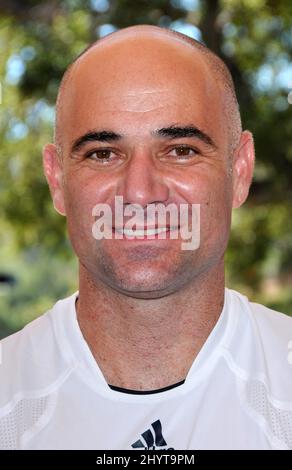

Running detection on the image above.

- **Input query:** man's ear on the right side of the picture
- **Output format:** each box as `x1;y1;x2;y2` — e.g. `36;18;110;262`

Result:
232;131;255;208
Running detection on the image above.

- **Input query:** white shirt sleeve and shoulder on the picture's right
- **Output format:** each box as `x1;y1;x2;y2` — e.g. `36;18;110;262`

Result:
222;289;292;449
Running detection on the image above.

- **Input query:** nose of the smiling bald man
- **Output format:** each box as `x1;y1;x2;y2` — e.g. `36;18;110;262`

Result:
119;149;169;207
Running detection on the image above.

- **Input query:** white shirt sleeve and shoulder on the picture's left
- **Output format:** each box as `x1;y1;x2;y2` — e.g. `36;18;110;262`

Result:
0;294;75;450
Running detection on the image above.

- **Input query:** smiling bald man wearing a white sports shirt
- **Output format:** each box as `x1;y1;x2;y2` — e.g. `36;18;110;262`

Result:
0;26;292;450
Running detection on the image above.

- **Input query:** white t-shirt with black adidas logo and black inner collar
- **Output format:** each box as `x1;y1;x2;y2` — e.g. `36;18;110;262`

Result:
0;289;292;450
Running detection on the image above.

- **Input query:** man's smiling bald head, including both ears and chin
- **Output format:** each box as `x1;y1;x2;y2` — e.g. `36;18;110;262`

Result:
44;26;254;297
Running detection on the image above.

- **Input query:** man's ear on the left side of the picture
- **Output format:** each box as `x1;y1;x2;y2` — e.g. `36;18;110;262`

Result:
43;144;66;215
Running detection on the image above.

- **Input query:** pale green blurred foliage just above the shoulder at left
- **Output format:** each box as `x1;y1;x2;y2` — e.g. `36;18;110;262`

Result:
0;227;78;337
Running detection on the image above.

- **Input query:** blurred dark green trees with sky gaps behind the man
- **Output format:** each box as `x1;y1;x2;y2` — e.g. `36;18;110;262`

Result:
0;0;292;338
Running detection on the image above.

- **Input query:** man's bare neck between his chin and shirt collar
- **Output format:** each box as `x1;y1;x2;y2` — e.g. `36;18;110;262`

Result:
77;260;224;390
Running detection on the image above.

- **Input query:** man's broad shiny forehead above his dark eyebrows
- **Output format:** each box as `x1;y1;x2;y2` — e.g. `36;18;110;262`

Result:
61;34;226;146
